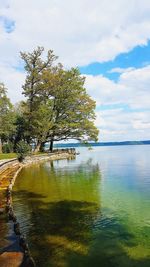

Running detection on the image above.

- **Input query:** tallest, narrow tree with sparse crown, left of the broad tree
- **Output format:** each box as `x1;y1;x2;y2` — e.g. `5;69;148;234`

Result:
21;47;57;150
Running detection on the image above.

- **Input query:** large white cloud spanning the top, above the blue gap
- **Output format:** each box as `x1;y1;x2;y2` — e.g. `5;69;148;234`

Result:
0;0;150;66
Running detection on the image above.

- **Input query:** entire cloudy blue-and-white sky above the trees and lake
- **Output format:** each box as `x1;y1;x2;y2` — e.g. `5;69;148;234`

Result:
0;0;150;141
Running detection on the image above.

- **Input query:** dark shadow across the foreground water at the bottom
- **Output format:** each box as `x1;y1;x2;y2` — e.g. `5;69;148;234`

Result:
12;191;150;267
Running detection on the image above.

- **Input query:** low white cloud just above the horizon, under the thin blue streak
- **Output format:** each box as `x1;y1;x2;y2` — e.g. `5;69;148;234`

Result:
96;109;150;141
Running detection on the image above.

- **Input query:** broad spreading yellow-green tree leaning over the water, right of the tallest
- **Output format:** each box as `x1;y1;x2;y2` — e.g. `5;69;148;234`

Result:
44;68;98;151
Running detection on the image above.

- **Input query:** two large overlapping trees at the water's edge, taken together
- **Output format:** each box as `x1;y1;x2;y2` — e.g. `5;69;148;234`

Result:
21;47;98;151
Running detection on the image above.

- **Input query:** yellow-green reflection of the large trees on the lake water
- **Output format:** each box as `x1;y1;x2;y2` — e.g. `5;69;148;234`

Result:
14;159;101;267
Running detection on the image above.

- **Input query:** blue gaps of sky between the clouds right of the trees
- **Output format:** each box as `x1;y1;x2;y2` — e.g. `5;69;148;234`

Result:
79;41;150;112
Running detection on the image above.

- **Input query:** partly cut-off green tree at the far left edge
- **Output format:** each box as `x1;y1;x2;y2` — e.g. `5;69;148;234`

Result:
0;83;15;153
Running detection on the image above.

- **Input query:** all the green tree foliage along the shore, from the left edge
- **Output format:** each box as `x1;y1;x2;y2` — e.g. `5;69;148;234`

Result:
0;47;98;154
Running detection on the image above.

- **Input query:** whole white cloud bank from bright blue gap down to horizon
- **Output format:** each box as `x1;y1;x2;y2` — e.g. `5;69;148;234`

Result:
86;66;150;141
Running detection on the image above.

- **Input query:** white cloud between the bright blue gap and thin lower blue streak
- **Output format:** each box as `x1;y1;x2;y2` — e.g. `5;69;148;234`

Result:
86;65;150;108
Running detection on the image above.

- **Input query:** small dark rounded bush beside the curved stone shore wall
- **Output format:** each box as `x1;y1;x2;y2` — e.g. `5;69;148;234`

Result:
16;141;31;162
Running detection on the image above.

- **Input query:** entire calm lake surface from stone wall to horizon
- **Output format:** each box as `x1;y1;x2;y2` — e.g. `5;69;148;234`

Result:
13;146;150;267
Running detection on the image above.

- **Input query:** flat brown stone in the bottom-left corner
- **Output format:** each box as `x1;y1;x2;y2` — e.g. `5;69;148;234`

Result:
0;252;24;267
